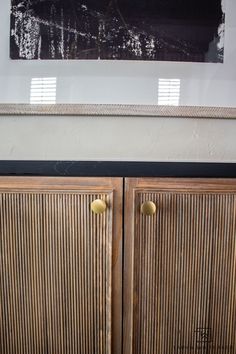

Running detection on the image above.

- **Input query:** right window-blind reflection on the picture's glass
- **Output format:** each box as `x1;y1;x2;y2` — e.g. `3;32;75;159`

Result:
158;79;180;106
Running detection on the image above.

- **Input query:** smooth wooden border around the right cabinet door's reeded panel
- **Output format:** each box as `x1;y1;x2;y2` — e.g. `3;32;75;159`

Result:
123;177;236;354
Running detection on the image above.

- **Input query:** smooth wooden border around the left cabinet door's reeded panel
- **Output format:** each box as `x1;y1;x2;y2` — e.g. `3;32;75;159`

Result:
0;176;123;354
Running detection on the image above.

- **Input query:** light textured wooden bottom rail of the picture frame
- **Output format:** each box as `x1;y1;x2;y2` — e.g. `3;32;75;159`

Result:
0;103;236;119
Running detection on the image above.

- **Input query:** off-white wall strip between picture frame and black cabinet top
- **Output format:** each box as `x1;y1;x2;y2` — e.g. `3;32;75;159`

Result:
0;117;236;162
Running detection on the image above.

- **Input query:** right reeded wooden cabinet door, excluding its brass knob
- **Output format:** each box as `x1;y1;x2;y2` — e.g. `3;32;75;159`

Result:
124;178;236;354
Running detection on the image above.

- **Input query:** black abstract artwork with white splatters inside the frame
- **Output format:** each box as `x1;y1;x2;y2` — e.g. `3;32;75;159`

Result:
10;0;225;63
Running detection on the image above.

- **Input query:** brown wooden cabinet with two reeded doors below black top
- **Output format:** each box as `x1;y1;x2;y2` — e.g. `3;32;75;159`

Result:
0;177;236;354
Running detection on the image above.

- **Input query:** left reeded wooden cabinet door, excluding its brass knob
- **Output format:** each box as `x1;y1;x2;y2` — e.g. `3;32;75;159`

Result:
0;177;122;354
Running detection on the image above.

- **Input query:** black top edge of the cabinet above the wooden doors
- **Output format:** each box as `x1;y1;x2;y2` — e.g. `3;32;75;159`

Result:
0;160;236;178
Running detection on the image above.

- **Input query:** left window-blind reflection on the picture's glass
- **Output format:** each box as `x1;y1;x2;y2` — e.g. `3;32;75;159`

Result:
30;77;57;104
